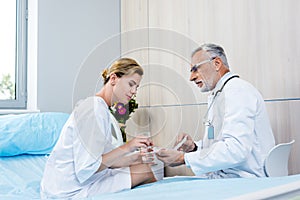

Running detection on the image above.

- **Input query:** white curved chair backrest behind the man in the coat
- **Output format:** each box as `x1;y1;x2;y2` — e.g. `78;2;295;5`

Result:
264;140;295;177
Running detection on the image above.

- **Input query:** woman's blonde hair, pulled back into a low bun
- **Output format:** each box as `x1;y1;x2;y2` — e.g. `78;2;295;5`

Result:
102;58;144;85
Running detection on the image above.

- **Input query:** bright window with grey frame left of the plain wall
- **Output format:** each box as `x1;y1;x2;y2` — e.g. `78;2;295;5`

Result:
0;0;27;109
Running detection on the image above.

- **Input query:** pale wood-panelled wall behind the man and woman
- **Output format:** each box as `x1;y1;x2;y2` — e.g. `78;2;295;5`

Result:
121;0;300;175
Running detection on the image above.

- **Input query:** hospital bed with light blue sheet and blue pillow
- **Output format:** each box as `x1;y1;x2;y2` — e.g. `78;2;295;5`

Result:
0;113;300;200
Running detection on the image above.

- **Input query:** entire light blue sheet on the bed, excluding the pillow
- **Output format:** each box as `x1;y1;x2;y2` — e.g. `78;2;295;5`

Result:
0;155;300;200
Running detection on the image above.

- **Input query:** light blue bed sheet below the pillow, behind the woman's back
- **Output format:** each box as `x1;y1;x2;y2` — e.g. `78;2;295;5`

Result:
0;155;47;200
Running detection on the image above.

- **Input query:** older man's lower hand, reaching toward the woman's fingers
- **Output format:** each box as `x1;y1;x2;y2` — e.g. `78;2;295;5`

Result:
156;149;185;167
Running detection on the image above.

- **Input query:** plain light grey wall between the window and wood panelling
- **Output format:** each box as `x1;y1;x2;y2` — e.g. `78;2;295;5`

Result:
37;0;120;112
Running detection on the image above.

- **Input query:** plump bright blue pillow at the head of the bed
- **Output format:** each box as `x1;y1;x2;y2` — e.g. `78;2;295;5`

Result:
0;112;69;156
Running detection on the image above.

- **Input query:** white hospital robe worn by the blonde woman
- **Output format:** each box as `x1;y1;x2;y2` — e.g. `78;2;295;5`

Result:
41;97;131;198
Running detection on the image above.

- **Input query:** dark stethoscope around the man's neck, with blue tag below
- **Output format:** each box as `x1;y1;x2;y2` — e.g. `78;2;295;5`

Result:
203;75;239;140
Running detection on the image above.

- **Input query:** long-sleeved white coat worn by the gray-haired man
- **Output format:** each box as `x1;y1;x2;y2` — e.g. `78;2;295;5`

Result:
185;72;275;178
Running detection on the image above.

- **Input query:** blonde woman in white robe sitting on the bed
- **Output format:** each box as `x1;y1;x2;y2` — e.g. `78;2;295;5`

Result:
41;58;156;199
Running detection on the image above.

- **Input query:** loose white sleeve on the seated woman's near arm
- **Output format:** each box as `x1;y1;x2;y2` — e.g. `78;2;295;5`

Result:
73;98;110;183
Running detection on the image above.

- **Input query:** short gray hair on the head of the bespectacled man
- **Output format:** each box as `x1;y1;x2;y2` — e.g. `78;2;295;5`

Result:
192;43;229;68
